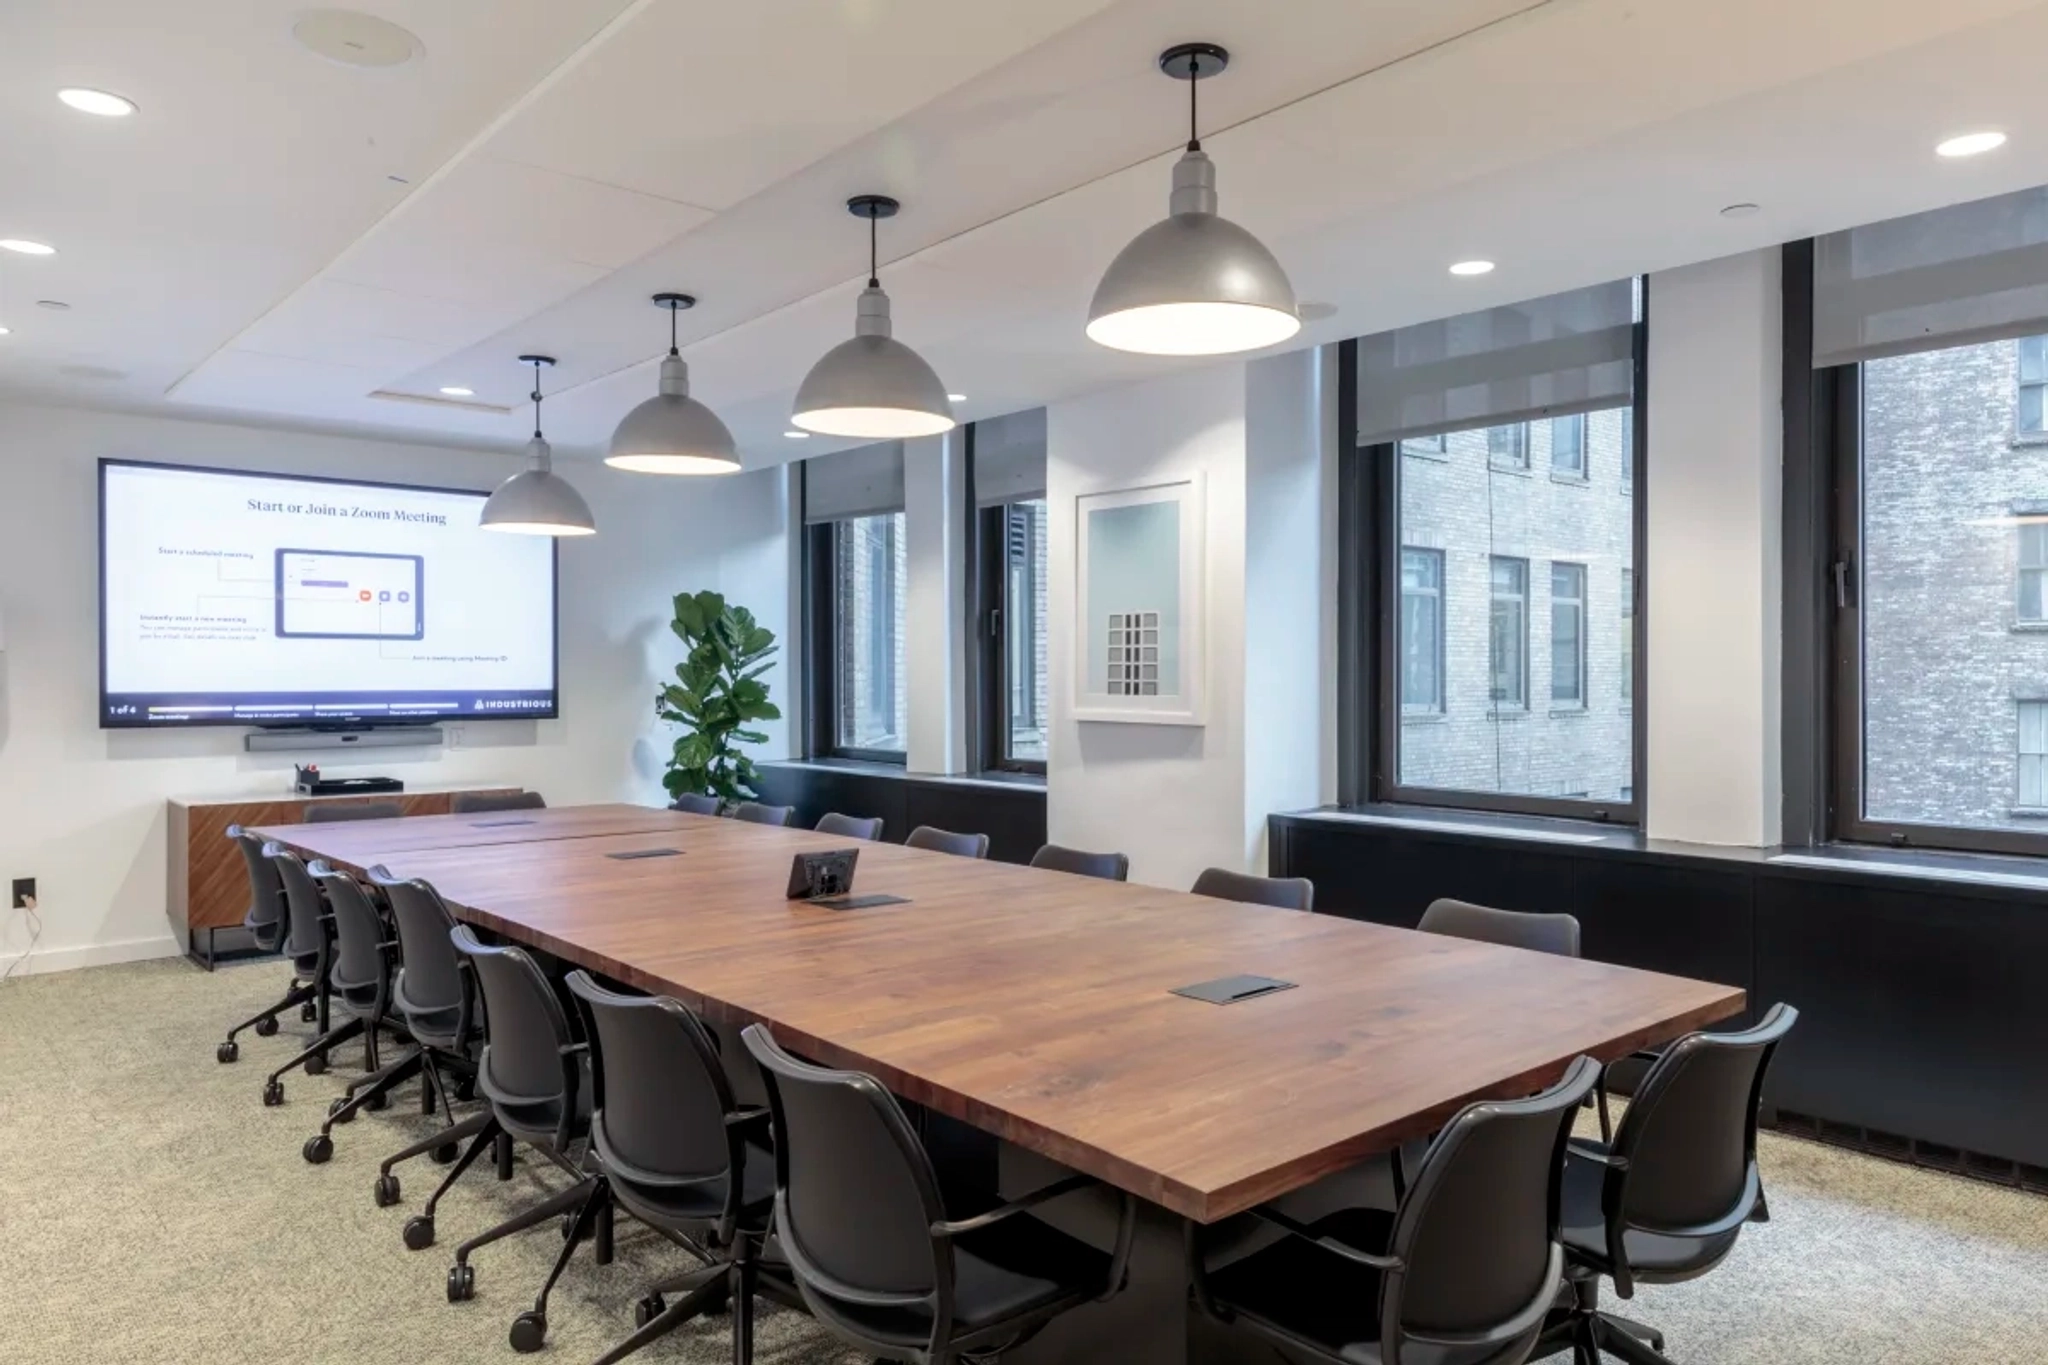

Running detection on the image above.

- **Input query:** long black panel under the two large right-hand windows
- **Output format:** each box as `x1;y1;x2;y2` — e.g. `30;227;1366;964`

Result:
1270;814;2048;1169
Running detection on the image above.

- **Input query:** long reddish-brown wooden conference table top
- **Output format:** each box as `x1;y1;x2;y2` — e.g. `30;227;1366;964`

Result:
266;814;1743;1222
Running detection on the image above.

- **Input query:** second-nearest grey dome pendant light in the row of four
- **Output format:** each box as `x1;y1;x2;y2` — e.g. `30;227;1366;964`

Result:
791;194;954;440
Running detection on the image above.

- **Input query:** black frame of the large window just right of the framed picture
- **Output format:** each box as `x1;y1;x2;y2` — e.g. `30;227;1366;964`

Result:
1337;276;1653;827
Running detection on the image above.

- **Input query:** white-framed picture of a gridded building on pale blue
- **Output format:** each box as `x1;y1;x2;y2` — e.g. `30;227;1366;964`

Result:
1069;471;1208;726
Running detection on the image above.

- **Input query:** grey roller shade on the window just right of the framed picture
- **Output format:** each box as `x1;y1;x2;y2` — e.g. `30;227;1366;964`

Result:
1358;280;1636;446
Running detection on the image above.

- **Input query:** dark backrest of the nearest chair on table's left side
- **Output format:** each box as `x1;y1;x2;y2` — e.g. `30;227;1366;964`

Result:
741;1023;952;1340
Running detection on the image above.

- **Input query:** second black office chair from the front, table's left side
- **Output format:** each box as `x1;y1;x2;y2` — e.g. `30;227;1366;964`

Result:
569;970;797;1365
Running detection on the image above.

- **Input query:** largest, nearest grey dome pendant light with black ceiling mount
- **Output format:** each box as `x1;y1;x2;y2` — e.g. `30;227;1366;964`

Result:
1087;43;1300;356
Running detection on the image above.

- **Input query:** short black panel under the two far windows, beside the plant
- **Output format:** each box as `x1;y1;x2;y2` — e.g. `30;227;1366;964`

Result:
758;763;1044;864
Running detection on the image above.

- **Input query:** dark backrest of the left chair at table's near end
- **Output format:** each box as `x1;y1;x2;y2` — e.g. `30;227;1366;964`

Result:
1380;1056;1599;1365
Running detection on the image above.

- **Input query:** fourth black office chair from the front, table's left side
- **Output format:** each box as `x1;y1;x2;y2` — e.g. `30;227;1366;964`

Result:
369;868;492;1209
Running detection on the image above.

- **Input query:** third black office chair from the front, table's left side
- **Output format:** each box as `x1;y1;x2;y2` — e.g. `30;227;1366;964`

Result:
438;925;612;1353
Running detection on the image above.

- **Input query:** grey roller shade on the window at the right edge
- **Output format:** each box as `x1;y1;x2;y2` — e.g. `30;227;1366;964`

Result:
1812;190;2048;368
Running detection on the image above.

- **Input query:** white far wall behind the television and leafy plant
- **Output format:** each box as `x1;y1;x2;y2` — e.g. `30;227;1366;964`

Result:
0;394;788;970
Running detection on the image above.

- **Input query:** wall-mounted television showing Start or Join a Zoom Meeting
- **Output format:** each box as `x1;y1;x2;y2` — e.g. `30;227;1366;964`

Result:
100;460;559;729
